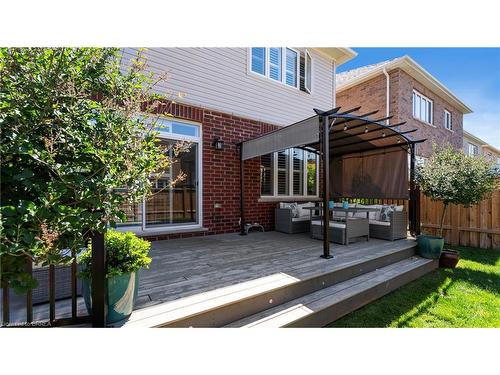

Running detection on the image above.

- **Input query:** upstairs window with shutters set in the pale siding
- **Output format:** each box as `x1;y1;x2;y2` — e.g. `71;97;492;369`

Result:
250;47;312;93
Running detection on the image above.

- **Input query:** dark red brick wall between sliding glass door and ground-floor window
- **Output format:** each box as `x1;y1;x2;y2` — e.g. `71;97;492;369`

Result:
143;103;276;240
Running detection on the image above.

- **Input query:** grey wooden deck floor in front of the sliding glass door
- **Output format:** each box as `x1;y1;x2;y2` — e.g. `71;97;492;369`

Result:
5;232;422;321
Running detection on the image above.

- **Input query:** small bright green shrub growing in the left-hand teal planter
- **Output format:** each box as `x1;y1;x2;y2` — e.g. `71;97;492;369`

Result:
78;230;151;279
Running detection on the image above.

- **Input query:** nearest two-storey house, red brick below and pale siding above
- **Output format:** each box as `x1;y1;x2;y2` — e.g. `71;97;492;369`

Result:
122;47;356;239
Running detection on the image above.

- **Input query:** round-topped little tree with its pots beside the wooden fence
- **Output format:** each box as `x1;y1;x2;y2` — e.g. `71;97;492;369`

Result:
416;146;498;268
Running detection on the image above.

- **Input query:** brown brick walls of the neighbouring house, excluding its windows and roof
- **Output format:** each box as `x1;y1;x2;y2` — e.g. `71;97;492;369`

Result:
337;69;463;157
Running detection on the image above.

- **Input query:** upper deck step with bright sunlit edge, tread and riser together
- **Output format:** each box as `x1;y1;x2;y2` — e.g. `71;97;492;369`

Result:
118;242;415;328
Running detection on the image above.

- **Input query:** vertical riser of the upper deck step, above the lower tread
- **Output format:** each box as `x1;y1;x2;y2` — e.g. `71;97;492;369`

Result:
157;247;416;328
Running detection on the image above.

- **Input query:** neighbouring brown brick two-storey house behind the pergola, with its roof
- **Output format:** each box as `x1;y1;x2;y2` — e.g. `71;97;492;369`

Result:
337;56;472;158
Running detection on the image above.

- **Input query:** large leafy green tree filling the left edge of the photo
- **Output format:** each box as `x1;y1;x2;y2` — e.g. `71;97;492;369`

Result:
0;48;184;292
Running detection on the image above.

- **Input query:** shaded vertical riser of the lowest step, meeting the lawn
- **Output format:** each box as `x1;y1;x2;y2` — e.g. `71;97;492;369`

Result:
283;260;439;328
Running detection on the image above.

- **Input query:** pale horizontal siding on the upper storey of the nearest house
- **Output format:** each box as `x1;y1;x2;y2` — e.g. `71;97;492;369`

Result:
122;48;334;126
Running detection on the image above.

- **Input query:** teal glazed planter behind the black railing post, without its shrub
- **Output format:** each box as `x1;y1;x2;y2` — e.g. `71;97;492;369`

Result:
82;272;139;324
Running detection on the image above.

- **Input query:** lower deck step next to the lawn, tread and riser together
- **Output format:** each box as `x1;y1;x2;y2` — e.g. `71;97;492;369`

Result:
226;256;437;328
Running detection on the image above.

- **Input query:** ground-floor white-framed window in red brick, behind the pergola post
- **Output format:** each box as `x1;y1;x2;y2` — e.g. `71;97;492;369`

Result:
260;148;318;197
